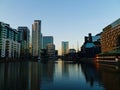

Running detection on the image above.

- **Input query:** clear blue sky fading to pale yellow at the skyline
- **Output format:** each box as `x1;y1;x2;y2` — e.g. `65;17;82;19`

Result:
0;0;120;54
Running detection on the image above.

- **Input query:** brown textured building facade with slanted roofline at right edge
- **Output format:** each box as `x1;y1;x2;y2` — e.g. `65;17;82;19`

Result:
101;19;120;53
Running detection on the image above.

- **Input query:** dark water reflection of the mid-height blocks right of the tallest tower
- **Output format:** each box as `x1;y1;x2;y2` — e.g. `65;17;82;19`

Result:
41;62;55;90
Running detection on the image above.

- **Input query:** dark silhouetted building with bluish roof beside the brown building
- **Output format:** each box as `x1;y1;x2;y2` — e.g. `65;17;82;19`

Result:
81;33;101;57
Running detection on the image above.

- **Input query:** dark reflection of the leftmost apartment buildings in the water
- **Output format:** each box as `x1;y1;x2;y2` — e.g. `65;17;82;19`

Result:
0;63;29;90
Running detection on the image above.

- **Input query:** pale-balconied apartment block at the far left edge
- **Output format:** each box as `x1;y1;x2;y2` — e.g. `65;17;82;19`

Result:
0;22;20;58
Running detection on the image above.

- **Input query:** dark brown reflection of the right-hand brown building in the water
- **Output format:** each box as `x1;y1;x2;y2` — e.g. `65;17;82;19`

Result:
99;65;120;90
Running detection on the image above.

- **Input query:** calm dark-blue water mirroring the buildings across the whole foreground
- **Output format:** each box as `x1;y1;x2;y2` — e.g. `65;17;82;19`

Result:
0;60;120;90
